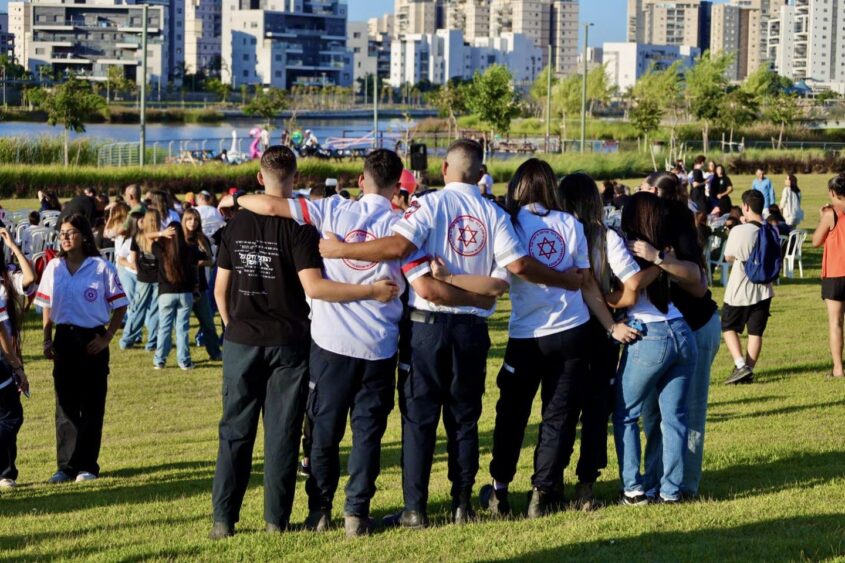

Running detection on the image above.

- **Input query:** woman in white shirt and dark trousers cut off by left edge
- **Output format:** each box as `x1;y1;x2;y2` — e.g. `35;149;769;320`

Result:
0;227;35;489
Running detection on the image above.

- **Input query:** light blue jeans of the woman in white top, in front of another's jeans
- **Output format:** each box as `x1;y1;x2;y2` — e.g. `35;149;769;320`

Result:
613;319;698;499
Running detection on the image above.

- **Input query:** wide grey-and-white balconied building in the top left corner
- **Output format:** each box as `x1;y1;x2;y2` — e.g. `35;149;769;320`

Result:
9;0;166;85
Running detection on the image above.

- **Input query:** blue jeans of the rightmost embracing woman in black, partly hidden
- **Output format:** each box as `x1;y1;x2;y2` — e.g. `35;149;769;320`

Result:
643;312;722;496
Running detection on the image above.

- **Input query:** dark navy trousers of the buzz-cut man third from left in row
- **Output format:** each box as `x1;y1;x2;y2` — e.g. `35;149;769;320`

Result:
399;313;490;511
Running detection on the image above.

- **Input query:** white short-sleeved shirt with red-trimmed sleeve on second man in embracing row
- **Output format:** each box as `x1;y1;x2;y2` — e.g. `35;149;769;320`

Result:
288;194;405;360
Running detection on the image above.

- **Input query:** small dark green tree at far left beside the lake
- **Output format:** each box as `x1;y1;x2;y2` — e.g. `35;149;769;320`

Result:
36;77;105;166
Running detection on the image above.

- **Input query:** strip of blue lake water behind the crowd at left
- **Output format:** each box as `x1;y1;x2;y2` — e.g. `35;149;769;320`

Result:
0;118;406;149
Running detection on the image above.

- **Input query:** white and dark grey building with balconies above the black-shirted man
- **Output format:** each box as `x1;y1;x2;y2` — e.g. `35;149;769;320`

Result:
221;0;353;88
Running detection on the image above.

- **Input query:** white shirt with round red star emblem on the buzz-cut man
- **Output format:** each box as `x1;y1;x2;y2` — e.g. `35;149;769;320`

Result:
393;183;525;318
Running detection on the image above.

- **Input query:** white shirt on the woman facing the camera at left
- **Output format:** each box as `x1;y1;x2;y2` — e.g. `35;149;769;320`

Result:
35;256;129;328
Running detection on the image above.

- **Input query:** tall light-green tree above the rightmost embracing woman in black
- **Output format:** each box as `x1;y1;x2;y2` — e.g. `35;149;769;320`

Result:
685;51;733;154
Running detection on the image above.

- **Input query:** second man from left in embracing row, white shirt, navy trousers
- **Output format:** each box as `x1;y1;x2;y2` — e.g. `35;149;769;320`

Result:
214;149;493;537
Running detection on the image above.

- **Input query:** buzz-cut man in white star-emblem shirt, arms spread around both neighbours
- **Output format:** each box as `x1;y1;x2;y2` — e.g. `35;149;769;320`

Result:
320;139;600;528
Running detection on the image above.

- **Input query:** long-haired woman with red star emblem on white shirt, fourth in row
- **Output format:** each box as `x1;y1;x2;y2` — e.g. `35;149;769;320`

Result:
481;158;633;518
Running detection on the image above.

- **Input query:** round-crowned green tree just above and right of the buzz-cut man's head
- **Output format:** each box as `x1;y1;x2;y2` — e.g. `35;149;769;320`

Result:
467;65;519;133
